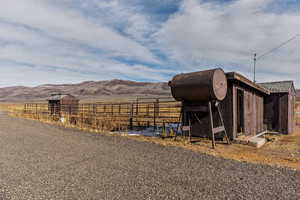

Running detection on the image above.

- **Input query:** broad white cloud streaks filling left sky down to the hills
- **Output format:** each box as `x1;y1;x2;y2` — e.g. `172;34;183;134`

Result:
0;0;172;86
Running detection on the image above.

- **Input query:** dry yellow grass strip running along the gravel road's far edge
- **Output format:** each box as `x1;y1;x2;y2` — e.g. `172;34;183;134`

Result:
0;102;300;170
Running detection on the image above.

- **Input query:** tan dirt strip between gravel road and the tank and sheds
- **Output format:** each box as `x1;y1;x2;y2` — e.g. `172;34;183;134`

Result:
127;128;300;170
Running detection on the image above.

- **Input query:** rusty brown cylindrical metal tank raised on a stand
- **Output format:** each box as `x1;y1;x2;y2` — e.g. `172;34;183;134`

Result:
169;68;227;102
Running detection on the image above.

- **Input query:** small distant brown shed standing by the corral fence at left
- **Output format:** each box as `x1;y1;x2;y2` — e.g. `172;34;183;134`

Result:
48;94;79;115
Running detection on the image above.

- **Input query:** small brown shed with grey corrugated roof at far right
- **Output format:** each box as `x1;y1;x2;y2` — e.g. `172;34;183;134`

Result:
260;81;296;134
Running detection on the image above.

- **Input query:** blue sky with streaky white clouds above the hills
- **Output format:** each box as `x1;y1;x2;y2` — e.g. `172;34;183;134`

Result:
0;0;300;87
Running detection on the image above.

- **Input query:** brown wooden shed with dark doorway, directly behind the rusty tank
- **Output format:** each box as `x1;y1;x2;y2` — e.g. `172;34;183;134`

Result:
185;72;270;140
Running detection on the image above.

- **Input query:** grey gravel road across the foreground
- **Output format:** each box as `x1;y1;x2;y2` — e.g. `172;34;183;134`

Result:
0;113;300;200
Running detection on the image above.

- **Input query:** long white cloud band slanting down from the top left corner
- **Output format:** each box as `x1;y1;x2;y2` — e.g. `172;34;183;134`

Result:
0;0;158;62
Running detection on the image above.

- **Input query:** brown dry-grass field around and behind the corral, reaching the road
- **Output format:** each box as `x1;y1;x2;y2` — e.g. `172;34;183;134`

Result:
0;102;300;170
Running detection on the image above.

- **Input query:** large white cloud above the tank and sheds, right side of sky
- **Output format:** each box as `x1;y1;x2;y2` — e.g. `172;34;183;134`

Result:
157;0;300;84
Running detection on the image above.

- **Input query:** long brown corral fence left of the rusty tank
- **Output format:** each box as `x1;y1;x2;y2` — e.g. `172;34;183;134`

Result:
5;98;181;131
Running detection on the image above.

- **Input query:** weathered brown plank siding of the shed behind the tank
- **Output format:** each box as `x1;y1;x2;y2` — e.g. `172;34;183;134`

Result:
191;83;265;139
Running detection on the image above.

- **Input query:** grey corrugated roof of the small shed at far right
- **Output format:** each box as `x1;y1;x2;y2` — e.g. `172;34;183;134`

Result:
259;81;294;93
